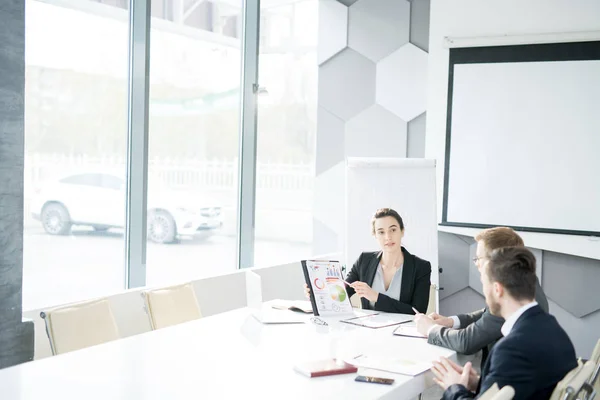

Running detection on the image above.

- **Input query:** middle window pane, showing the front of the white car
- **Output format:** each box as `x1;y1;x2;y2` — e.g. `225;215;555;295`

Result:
146;0;242;286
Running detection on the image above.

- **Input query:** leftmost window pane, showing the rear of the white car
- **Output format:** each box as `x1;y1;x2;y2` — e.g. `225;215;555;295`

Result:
23;0;128;310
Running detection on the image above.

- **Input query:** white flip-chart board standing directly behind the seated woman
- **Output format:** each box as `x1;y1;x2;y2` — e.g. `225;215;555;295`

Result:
344;158;439;296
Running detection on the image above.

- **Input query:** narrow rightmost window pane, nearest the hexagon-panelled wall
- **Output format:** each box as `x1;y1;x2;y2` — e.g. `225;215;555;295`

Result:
254;0;318;265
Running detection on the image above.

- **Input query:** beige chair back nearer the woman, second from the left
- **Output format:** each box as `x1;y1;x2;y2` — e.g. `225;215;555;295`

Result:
142;283;202;329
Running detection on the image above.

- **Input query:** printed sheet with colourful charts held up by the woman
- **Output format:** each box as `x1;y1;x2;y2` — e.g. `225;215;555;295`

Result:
302;260;353;317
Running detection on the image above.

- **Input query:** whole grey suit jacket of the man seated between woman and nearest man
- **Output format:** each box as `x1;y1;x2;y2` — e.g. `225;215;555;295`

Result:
427;280;548;356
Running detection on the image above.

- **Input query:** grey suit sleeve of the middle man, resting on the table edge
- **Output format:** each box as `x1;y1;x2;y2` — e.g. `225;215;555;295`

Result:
427;310;504;354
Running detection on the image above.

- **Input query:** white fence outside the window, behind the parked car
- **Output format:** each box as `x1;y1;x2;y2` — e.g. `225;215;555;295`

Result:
24;154;315;243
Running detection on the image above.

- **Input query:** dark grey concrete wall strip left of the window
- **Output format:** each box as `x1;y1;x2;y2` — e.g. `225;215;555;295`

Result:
0;0;33;368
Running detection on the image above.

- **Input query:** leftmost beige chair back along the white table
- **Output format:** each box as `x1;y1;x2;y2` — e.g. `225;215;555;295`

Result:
40;299;120;355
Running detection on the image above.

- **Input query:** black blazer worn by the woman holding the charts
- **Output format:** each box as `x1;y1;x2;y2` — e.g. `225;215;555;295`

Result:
346;247;431;314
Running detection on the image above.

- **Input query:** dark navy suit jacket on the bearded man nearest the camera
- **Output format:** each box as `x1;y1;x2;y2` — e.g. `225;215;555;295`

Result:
442;306;577;400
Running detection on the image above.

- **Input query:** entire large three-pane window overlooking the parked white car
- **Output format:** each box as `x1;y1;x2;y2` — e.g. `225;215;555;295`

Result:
23;0;318;310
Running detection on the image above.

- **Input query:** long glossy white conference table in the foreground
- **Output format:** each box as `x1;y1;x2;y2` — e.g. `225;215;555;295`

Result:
0;308;455;400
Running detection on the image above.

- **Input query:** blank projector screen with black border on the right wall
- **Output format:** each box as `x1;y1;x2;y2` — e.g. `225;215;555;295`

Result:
442;42;600;235
